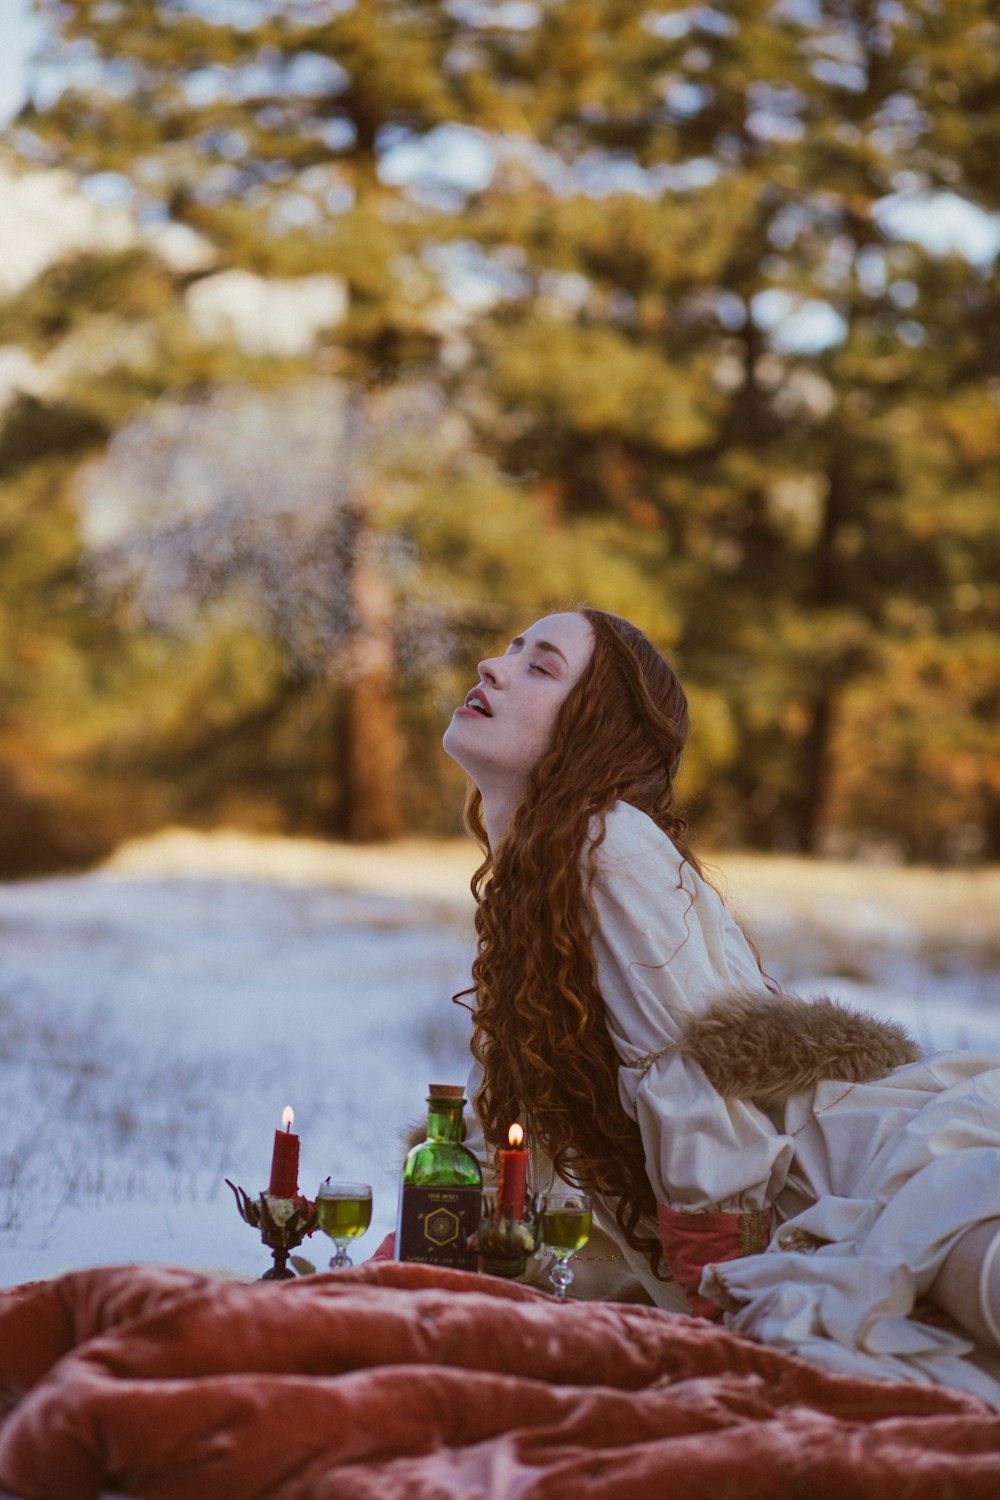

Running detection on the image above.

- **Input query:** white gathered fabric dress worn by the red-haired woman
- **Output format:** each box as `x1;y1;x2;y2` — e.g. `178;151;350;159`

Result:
471;803;1000;1407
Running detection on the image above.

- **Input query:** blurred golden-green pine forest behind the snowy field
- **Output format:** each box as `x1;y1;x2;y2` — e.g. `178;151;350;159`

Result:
0;0;1000;878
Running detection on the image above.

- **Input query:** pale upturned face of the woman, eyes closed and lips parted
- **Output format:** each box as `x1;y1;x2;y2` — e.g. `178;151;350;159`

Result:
444;614;594;794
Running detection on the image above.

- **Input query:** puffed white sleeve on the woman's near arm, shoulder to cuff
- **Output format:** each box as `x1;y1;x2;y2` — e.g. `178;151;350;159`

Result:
585;804;793;1223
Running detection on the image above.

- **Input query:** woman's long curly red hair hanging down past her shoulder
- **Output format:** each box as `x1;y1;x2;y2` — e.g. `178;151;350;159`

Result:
456;609;719;1275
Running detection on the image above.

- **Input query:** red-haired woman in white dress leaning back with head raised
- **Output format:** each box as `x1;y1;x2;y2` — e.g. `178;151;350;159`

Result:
444;609;1000;1406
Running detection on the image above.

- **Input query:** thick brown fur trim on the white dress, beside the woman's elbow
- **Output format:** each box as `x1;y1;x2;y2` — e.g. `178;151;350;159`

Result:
673;992;922;1104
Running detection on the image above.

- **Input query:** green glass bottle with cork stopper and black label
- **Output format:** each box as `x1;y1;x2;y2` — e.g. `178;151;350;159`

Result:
396;1083;483;1271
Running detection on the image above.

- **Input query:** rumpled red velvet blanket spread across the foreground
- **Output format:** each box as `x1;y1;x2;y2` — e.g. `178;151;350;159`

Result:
0;1263;1000;1500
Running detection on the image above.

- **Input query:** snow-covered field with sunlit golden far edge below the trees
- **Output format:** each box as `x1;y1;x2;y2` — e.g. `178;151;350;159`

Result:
0;833;1000;1284
